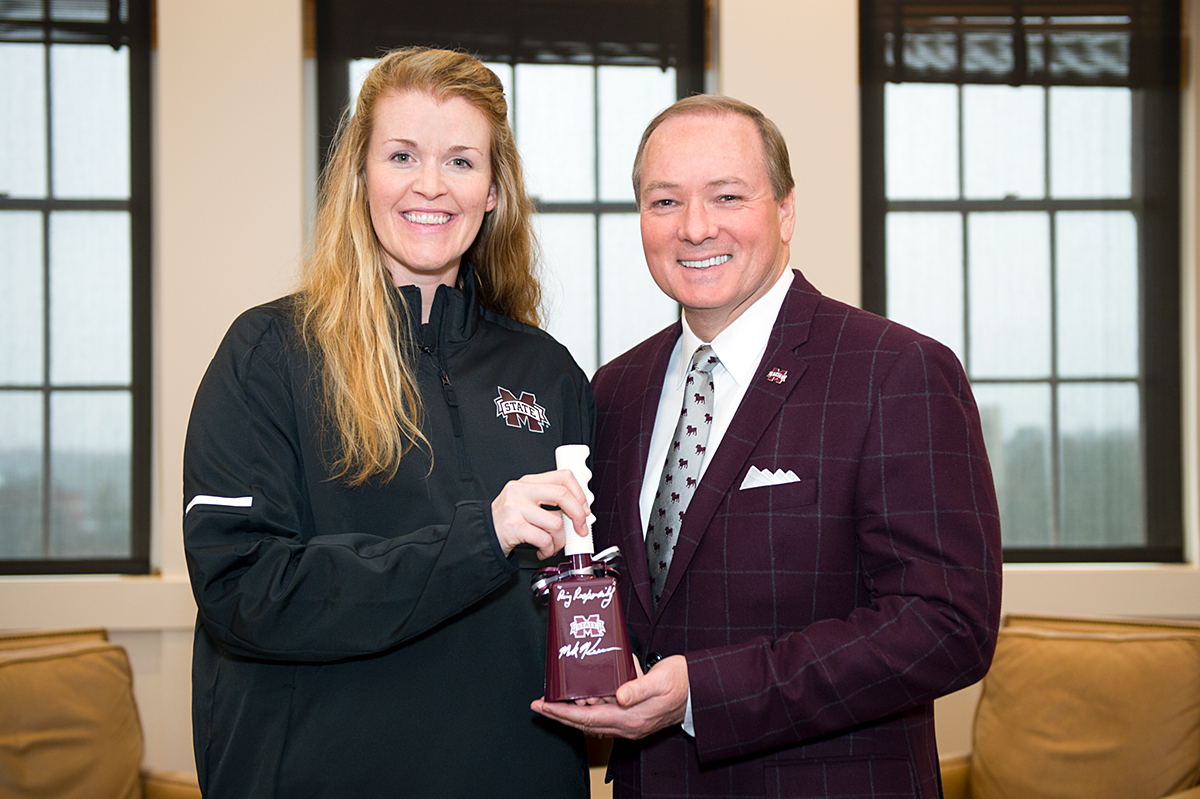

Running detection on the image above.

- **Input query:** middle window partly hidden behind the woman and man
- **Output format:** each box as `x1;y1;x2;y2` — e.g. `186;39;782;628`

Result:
317;0;704;373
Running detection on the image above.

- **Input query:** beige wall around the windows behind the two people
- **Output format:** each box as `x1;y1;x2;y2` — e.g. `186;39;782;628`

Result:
0;0;1200;769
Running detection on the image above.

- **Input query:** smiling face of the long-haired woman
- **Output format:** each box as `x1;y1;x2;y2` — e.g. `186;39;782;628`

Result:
366;91;496;287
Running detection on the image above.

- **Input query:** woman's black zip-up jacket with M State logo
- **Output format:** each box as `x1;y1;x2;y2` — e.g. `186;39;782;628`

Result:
184;265;594;799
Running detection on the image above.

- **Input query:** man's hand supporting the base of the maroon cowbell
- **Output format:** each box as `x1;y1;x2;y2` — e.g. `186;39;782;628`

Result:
529;655;688;740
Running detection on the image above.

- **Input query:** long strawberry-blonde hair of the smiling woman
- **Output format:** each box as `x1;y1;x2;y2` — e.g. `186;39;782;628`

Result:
298;48;541;486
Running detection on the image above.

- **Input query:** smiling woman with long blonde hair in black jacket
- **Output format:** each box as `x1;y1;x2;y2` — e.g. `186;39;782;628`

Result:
184;48;594;798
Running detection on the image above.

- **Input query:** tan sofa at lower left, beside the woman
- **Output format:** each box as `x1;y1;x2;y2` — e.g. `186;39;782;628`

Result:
0;630;200;799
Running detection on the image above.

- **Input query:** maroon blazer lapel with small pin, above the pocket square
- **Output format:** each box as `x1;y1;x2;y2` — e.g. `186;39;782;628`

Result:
646;272;821;609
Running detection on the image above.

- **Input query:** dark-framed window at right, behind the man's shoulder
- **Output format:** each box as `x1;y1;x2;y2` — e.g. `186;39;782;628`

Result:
862;0;1182;561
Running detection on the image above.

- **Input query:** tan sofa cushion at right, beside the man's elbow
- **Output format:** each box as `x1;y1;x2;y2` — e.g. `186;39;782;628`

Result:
970;626;1200;799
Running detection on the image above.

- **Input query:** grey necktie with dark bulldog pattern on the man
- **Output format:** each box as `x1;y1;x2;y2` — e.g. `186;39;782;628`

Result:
646;344;720;605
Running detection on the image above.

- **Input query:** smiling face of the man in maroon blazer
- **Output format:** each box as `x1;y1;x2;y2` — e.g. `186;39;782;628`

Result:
640;114;796;341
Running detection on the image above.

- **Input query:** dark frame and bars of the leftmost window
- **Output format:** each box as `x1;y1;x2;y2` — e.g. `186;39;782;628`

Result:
0;0;152;575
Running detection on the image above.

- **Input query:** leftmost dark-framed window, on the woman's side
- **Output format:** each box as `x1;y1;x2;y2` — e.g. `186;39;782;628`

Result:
0;0;150;573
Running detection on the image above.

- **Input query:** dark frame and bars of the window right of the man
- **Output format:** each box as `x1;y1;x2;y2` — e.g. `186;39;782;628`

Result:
859;0;1184;563
